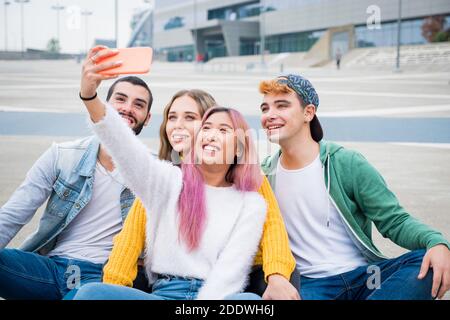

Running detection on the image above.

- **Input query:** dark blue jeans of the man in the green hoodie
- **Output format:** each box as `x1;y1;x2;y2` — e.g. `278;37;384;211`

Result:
300;250;433;300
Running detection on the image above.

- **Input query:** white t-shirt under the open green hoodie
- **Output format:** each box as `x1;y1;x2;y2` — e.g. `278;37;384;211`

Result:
275;156;367;278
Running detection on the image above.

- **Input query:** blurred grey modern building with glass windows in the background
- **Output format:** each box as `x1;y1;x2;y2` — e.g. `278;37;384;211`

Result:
148;0;450;61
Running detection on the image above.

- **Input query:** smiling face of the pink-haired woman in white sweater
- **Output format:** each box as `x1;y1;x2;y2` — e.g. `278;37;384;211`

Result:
195;111;237;165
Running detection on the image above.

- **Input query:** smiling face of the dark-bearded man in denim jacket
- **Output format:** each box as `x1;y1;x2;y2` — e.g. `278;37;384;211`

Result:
108;81;151;135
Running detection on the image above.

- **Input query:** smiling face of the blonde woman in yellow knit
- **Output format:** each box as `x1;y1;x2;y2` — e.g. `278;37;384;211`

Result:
166;95;202;153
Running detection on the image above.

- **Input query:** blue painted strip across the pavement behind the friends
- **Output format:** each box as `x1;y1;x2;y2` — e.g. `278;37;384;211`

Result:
0;112;450;143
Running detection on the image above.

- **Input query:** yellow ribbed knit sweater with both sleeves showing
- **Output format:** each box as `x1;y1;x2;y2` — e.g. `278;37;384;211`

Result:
103;177;295;287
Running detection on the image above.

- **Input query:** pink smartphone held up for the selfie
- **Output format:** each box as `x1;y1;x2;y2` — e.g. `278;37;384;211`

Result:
97;47;153;75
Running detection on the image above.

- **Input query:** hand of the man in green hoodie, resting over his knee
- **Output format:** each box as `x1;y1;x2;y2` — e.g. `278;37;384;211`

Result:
418;244;450;299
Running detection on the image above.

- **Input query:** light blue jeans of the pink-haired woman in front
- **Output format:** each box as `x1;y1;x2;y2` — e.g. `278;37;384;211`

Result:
74;276;261;300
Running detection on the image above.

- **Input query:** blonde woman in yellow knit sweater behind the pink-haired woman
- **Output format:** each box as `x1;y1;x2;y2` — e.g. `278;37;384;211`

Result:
103;89;299;300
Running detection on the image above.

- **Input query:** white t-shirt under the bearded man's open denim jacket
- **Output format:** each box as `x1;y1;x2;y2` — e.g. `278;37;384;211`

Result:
48;162;124;264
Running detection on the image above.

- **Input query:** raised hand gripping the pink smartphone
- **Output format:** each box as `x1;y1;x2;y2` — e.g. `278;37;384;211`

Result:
80;46;122;98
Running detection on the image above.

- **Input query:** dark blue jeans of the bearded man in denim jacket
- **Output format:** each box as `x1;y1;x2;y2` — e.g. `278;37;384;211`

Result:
0;249;103;300
